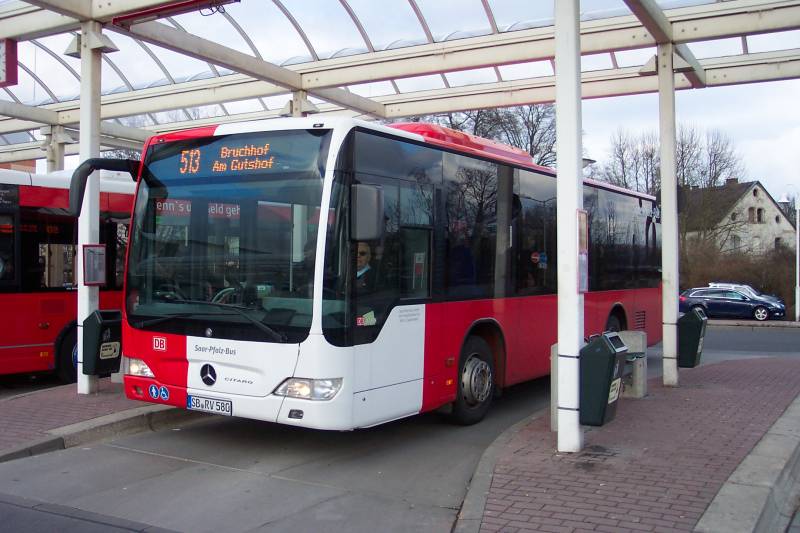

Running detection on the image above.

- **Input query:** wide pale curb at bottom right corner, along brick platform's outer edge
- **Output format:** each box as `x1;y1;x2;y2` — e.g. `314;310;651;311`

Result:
694;397;800;533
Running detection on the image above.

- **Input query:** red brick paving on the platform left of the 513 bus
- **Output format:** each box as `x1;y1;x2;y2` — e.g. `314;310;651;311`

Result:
0;379;139;451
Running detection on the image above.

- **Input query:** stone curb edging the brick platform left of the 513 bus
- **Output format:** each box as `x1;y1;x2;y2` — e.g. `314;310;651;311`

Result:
0;405;208;463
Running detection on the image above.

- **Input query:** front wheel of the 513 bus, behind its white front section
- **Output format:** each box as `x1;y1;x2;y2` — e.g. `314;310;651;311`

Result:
453;337;494;426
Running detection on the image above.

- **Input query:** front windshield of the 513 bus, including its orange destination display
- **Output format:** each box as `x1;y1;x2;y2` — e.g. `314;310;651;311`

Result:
126;130;330;342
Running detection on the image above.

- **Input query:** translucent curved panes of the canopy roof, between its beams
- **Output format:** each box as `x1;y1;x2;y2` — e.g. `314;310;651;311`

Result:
0;0;800;145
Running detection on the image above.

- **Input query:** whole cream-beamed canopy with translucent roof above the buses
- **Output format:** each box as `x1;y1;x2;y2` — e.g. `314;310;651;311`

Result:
0;0;800;162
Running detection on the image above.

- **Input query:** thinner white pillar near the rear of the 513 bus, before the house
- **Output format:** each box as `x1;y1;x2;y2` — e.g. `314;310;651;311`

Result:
656;43;679;387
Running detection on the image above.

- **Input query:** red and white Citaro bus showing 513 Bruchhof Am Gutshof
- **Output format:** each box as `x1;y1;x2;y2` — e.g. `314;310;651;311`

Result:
123;117;661;430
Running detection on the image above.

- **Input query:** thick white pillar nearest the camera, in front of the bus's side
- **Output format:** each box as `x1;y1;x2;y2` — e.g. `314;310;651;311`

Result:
555;0;583;452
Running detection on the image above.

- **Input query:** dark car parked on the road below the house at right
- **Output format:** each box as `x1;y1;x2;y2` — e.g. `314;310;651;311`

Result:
679;287;786;320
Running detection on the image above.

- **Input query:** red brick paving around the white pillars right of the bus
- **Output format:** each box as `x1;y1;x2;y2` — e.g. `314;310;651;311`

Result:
481;358;800;533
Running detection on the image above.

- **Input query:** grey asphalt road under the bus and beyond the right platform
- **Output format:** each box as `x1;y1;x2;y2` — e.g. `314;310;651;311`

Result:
0;326;800;533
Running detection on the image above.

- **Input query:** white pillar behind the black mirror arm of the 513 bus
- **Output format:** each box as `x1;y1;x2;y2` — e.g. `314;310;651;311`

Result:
75;21;102;394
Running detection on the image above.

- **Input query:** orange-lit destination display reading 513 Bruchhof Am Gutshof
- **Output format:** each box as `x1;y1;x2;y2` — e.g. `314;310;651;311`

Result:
147;130;328;181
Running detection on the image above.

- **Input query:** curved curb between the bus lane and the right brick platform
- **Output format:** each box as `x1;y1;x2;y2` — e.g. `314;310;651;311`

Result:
451;406;550;533
